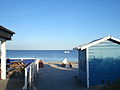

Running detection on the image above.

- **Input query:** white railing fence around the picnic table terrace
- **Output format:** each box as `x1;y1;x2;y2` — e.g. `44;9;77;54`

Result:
10;58;39;90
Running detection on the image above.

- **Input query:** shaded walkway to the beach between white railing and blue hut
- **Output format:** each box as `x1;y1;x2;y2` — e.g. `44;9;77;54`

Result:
32;63;101;90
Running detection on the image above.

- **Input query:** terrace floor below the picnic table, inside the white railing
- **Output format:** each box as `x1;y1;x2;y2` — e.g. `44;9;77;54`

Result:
0;72;24;90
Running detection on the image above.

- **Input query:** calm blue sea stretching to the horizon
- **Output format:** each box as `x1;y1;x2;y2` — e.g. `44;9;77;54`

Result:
7;50;78;62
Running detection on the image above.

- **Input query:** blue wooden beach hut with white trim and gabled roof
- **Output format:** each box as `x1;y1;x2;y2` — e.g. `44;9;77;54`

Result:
75;36;120;88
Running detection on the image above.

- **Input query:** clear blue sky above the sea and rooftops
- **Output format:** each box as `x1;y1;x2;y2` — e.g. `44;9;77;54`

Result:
0;0;120;50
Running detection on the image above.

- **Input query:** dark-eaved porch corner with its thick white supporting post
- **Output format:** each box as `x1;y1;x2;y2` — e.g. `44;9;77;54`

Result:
0;25;15;80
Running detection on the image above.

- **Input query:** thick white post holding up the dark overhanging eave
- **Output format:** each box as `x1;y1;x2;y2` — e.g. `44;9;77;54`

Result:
1;40;6;80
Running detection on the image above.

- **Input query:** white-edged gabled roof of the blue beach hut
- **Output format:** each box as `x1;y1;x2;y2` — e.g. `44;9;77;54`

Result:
74;36;120;50
